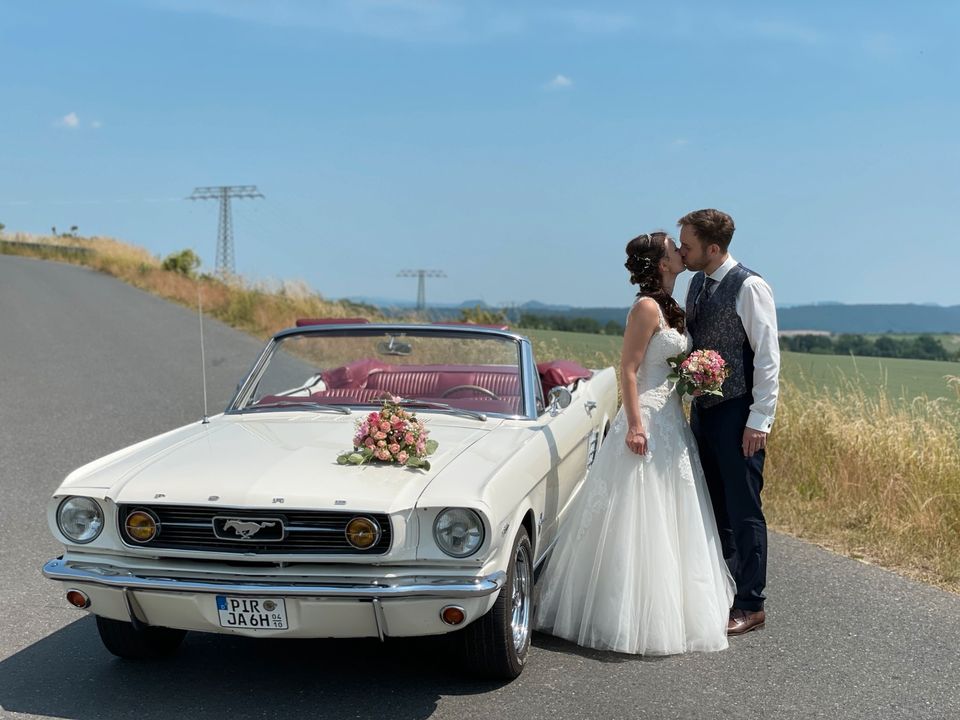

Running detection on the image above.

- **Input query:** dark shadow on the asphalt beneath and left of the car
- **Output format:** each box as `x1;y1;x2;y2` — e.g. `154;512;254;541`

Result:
0;617;503;720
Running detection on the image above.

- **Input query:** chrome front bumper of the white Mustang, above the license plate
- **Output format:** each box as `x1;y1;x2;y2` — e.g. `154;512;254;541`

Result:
43;558;507;600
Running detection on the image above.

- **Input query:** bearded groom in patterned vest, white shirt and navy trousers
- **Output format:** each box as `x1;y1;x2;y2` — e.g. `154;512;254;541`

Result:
677;210;780;635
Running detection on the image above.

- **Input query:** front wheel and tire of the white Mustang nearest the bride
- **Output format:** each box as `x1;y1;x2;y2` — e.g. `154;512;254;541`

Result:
462;527;534;680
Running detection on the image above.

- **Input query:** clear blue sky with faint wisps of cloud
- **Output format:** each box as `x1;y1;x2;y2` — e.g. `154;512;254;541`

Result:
0;0;960;306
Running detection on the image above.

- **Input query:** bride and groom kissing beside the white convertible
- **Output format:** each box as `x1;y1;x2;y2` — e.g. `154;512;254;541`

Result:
537;209;780;655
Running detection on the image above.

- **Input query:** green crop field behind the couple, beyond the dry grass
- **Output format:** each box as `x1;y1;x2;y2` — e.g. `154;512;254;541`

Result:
518;329;960;399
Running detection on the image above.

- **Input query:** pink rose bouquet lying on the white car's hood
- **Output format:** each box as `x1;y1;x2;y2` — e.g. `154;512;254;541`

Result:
337;398;437;470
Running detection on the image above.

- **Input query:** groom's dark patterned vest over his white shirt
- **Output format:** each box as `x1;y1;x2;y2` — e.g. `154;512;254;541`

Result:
687;263;757;407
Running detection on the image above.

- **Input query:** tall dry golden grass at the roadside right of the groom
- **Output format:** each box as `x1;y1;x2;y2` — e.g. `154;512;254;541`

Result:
764;376;960;591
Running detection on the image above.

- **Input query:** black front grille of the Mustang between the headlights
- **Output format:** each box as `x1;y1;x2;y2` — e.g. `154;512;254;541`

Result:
117;505;392;555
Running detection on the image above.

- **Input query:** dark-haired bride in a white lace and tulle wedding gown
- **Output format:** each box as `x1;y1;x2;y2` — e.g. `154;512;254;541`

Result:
537;232;734;655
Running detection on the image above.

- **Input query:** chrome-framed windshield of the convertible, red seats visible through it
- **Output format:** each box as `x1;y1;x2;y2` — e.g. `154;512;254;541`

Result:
233;328;524;415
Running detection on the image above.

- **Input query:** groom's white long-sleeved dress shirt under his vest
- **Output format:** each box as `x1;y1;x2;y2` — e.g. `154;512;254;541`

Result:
687;255;780;432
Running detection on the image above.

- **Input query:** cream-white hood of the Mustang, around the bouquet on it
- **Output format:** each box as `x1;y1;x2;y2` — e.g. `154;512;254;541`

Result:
63;413;500;512
